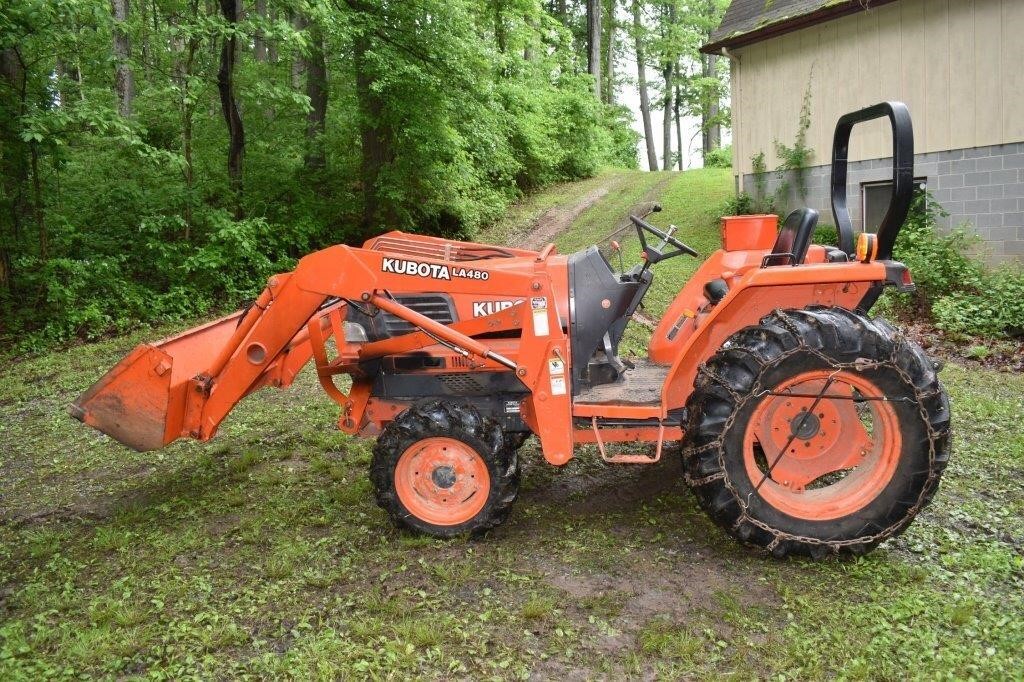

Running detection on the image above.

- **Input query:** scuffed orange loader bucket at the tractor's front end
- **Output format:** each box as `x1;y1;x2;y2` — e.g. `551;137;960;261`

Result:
68;312;243;453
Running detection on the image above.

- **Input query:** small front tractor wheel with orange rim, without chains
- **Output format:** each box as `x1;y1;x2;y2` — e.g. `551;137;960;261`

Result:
370;400;519;538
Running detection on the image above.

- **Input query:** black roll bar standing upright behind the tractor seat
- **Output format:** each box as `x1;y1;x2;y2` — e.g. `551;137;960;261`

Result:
831;101;913;259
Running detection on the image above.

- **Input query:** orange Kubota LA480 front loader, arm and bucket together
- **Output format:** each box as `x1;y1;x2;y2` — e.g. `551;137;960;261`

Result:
70;241;571;462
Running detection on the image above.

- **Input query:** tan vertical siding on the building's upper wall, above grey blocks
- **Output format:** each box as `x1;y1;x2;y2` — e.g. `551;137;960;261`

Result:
734;0;1024;173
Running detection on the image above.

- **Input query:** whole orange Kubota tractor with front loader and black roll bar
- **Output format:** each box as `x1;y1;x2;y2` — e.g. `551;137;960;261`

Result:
71;102;949;557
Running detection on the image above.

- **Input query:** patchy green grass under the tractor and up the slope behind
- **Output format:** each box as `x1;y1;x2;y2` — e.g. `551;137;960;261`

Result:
0;166;1024;680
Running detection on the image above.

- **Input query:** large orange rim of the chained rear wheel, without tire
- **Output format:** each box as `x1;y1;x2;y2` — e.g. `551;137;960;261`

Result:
743;370;902;521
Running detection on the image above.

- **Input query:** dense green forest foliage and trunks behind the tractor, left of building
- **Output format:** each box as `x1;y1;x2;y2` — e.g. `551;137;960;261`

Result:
0;0;721;346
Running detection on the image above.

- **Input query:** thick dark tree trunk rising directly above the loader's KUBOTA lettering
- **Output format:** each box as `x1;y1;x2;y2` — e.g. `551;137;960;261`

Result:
353;35;396;235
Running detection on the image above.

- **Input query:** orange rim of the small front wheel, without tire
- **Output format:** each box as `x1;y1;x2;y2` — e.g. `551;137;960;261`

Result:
394;437;490;525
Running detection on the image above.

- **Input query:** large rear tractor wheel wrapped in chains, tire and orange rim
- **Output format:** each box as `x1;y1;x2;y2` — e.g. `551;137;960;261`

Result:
684;308;949;557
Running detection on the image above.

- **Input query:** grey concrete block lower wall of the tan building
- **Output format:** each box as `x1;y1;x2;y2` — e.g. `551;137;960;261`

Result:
742;142;1024;264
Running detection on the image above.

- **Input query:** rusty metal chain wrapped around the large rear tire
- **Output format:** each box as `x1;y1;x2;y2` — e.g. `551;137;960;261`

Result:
684;308;950;553
